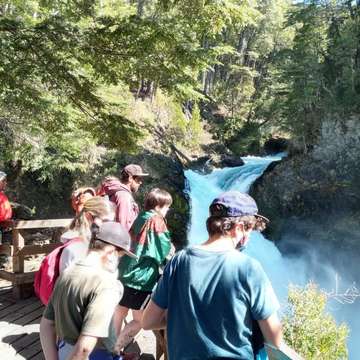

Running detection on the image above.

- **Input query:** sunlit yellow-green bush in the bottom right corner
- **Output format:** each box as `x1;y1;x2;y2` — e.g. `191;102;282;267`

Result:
283;283;349;360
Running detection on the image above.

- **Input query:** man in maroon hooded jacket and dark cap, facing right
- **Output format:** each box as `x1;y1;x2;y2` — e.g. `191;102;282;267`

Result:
98;164;149;231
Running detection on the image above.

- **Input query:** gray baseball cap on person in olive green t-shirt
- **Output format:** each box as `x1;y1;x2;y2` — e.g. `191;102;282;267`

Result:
96;221;137;259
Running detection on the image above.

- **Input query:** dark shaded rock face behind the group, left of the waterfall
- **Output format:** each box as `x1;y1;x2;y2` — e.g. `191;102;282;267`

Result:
7;151;189;248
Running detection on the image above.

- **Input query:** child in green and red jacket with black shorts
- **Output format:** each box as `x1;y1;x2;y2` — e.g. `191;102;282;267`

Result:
116;188;172;350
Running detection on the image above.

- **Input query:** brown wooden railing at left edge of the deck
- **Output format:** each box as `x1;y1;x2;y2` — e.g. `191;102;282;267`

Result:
0;219;72;299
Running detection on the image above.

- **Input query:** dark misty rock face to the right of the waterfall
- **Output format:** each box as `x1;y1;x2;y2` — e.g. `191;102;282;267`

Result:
251;118;360;255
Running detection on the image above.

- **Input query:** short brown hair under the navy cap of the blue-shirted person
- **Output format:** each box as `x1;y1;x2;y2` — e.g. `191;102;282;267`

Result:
206;215;266;236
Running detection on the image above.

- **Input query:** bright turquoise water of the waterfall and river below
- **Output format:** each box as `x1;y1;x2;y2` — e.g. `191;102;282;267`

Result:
185;154;360;359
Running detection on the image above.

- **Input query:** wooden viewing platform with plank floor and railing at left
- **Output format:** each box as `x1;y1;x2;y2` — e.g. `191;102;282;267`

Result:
0;219;166;360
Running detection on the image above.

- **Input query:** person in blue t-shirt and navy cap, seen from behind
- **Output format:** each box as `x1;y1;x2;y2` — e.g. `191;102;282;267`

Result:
142;191;282;360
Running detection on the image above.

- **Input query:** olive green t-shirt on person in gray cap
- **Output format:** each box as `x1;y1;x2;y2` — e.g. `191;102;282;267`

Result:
44;258;123;352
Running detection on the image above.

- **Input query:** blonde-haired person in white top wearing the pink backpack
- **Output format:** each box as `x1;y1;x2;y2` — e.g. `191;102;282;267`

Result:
60;196;115;273
